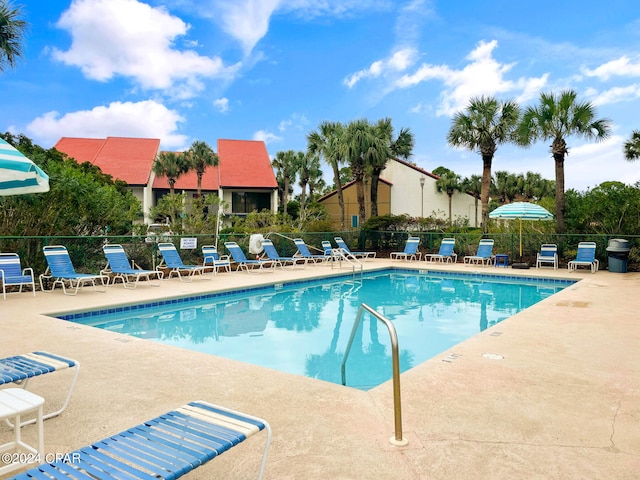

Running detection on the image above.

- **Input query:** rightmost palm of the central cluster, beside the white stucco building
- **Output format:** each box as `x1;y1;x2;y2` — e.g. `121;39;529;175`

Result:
368;118;415;217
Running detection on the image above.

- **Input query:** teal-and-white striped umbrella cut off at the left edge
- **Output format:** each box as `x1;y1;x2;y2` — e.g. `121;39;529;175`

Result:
0;138;49;195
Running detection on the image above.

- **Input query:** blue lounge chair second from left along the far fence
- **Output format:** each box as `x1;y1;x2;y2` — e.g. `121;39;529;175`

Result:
39;245;109;295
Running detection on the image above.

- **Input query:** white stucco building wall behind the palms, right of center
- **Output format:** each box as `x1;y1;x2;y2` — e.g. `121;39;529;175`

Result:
381;160;475;226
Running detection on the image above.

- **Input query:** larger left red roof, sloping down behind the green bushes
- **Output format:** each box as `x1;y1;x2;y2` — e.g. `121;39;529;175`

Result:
54;137;160;185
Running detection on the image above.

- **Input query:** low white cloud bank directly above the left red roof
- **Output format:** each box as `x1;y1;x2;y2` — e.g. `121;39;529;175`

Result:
26;100;188;150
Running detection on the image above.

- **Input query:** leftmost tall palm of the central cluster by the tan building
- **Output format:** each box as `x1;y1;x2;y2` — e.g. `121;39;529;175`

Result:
307;122;345;229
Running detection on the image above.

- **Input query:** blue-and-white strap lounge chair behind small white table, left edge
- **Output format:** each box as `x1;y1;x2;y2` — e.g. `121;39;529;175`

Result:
0;352;80;425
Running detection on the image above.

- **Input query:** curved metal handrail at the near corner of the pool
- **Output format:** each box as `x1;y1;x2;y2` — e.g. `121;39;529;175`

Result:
340;303;409;447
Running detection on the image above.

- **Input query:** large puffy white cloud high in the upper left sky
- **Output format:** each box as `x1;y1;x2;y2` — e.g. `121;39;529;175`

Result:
52;0;239;99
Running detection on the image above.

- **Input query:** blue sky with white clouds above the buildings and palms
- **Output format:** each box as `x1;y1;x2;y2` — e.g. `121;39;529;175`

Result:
0;0;640;190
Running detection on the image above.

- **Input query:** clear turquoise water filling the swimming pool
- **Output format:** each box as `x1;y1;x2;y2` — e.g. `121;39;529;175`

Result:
58;270;573;390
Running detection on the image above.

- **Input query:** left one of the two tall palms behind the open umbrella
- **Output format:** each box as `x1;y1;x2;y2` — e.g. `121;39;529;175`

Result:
447;96;520;232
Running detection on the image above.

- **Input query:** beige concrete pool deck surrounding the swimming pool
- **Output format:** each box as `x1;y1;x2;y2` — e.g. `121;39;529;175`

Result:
0;259;640;480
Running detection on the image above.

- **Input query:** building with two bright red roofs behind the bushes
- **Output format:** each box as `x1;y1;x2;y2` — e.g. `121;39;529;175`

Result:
55;137;278;223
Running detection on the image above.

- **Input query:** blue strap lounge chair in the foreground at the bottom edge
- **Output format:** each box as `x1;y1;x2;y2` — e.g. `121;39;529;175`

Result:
13;401;271;480
